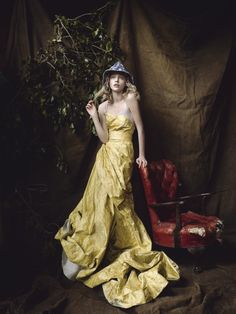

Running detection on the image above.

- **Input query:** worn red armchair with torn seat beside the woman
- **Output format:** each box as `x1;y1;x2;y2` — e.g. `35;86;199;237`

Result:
139;160;223;271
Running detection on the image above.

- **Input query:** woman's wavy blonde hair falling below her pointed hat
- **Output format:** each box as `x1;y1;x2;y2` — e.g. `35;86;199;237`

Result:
94;75;140;103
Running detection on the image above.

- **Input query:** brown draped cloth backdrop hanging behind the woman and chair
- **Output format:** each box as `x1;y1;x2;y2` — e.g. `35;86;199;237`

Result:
2;0;236;241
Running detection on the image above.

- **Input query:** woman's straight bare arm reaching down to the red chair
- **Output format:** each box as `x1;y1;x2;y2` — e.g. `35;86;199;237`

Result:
126;93;147;167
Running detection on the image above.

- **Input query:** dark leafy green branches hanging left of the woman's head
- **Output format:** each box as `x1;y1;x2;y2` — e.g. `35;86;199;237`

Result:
21;2;123;133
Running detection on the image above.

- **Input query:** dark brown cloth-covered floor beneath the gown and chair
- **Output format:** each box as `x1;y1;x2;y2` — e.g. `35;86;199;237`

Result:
0;239;236;314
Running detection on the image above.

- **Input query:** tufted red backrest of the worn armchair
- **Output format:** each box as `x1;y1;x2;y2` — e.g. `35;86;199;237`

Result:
139;159;178;223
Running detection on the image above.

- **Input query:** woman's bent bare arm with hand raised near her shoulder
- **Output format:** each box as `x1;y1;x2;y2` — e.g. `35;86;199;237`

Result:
86;100;108;143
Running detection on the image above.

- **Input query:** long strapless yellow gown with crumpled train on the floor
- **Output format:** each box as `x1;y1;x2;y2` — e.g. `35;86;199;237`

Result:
55;113;179;308
